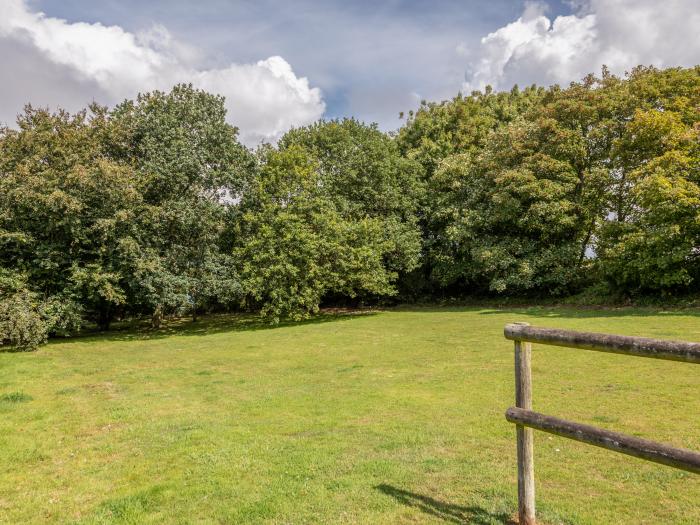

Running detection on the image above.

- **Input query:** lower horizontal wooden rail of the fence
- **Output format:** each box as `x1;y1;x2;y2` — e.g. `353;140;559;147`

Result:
506;407;700;474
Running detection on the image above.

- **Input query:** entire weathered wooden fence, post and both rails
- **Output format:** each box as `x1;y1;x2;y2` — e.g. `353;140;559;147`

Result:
504;323;700;525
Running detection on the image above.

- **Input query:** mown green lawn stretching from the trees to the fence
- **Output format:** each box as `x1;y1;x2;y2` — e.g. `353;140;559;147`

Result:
0;307;700;524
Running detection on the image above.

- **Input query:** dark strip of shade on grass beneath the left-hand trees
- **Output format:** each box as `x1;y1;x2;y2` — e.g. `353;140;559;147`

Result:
58;310;377;342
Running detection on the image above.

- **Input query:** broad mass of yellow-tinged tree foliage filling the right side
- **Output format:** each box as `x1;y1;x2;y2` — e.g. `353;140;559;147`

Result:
399;67;700;294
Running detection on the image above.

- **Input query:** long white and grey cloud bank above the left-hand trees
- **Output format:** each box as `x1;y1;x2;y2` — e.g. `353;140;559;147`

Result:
0;0;325;144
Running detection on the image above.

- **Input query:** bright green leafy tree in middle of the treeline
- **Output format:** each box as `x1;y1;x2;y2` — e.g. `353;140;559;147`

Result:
234;144;397;322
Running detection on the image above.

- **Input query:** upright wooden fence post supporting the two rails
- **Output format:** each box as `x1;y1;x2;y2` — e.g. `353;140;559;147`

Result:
515;323;535;525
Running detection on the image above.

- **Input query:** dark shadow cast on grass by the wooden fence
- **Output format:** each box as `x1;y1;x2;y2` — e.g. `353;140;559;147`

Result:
374;483;515;525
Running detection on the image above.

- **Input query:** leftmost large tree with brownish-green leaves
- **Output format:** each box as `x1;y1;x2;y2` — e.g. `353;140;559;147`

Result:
0;106;141;328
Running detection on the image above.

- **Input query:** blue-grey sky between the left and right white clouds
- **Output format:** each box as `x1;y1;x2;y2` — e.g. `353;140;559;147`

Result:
30;0;571;121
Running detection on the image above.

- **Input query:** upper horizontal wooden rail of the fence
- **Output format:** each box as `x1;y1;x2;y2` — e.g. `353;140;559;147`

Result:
503;324;700;364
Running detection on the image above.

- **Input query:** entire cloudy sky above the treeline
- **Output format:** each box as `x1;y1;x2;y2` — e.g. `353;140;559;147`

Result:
0;0;700;145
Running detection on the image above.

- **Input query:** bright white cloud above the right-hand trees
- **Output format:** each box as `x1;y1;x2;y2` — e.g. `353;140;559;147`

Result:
457;0;700;92
